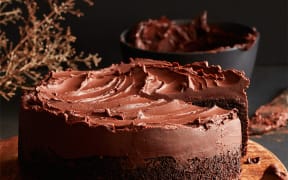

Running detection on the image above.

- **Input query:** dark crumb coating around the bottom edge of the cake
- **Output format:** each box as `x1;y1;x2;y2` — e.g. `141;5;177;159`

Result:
20;150;241;180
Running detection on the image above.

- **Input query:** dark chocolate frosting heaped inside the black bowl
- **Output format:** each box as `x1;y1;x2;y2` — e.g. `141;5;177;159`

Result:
128;12;258;52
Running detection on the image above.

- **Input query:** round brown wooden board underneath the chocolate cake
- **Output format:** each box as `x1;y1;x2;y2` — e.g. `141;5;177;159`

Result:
0;136;287;180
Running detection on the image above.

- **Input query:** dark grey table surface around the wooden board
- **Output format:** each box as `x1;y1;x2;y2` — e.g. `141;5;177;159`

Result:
0;66;288;168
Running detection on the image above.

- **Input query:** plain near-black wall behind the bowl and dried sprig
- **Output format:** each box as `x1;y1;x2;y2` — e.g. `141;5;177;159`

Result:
67;0;288;66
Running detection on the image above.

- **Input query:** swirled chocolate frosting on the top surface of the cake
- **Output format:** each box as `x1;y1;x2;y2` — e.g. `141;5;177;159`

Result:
26;60;247;129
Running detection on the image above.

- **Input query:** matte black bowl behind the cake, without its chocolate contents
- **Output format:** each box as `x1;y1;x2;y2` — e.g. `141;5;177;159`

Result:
120;20;260;78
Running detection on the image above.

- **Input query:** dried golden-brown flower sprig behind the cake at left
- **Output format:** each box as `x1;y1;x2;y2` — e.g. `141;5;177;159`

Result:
0;0;101;100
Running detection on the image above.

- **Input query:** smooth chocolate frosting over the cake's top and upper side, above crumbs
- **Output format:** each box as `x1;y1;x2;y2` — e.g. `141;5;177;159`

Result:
20;59;249;161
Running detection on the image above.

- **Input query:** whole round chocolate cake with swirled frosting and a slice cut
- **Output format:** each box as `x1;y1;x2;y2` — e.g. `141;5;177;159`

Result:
19;59;249;179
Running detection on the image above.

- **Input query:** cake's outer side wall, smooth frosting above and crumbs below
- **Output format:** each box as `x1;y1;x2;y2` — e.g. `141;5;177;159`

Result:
19;96;241;179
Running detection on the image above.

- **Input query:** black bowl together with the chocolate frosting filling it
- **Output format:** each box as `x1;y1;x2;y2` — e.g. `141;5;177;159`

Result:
120;11;260;78
